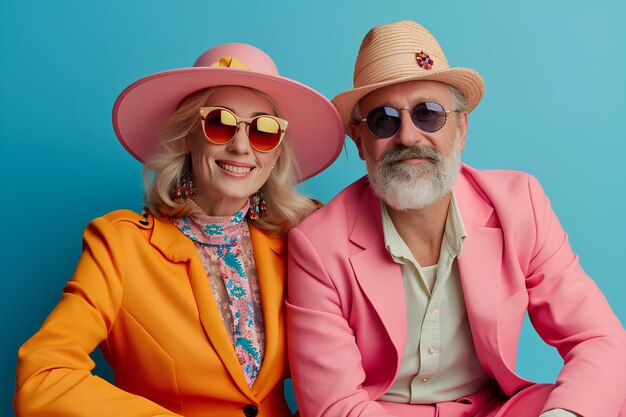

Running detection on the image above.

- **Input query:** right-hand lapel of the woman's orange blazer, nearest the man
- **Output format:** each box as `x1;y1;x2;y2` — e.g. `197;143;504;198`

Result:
250;224;286;399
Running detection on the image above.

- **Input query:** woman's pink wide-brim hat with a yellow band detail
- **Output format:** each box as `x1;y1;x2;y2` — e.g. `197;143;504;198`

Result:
113;43;344;181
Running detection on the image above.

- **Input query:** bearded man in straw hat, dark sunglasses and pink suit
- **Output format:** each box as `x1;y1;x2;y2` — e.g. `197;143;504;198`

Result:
287;21;626;417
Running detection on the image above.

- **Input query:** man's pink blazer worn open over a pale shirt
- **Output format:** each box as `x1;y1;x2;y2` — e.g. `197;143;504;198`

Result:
287;165;626;417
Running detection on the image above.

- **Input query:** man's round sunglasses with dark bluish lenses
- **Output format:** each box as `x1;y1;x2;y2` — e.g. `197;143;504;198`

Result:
359;101;458;139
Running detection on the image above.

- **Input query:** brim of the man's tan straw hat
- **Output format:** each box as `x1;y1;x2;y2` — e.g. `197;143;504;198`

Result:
331;68;485;136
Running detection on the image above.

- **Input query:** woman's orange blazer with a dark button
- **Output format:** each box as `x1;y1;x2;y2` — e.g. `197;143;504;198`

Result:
14;210;291;417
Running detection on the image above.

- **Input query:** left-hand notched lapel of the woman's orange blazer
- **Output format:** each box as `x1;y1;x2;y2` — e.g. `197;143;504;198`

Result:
150;214;255;401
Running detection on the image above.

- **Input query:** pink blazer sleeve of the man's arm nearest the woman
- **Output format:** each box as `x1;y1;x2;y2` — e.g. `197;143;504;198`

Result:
287;229;389;417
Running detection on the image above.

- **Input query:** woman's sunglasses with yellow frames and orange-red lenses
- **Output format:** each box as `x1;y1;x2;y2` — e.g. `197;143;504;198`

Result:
200;107;288;152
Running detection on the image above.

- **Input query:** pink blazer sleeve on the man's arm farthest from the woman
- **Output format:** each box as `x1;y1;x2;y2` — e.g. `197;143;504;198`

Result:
526;176;626;417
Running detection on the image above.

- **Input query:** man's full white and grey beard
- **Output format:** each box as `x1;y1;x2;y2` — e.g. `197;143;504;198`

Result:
365;136;461;210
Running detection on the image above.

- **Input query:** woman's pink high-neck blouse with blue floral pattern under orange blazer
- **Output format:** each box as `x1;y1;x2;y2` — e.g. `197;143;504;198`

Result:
171;202;265;386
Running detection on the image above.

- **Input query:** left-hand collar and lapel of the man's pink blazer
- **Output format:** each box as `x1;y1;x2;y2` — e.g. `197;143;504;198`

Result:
348;187;407;364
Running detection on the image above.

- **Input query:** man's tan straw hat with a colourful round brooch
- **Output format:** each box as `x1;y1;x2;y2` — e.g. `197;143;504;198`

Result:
332;20;485;134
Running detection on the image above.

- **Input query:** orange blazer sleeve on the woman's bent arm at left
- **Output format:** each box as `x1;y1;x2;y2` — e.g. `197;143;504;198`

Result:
14;218;177;417
